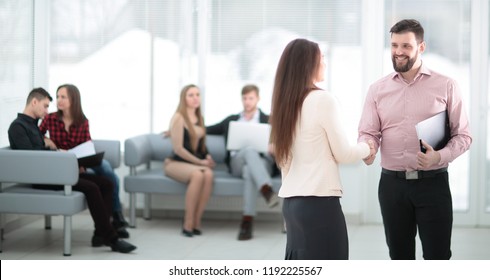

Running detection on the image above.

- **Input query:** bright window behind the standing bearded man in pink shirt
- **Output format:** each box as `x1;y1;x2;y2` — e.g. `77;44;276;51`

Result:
384;0;471;211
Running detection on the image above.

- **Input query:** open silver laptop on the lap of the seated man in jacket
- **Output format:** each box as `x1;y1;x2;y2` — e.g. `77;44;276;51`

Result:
226;121;271;153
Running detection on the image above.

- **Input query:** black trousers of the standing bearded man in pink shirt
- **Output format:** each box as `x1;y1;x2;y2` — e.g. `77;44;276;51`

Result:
378;171;453;260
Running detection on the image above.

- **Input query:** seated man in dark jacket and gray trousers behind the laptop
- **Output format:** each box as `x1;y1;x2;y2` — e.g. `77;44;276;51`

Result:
206;85;279;240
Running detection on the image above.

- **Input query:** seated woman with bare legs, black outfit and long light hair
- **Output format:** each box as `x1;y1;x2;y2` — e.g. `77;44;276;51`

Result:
164;84;215;237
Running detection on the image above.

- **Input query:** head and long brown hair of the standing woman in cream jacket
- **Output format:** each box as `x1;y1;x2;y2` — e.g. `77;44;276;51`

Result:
269;39;321;167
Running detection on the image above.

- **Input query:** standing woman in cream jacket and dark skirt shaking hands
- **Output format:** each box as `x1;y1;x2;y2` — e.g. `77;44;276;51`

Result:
270;39;373;259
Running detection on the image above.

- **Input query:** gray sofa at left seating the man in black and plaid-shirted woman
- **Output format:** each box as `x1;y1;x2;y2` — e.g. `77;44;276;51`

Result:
0;140;121;256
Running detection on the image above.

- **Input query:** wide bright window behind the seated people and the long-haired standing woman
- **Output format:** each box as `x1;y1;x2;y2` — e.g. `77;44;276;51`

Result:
49;0;362;144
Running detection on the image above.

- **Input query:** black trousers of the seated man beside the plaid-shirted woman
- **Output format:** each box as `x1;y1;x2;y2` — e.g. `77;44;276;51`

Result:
33;173;117;244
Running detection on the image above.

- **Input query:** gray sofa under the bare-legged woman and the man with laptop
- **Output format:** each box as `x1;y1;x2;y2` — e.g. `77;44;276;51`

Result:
124;134;281;227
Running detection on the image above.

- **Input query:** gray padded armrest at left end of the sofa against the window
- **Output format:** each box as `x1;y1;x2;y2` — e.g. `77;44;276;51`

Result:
124;134;152;167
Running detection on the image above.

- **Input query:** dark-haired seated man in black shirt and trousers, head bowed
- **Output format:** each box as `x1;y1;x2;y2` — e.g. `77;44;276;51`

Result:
8;88;136;253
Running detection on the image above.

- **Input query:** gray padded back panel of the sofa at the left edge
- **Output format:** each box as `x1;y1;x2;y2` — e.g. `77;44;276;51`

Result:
0;149;78;186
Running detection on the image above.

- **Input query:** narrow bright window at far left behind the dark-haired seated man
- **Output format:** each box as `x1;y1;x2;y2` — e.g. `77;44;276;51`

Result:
0;0;33;147
